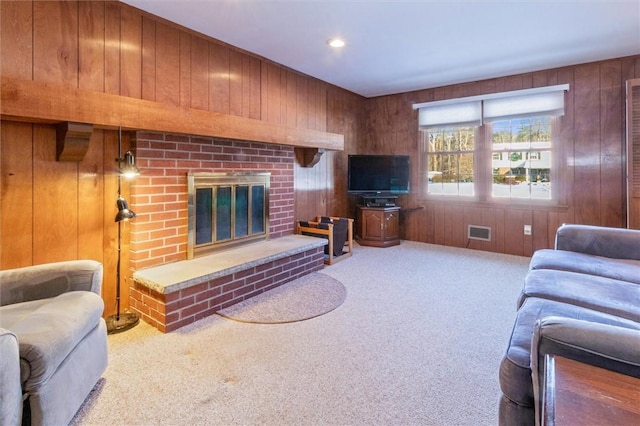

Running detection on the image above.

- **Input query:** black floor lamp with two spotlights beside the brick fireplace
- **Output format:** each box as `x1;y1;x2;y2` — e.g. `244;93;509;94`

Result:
105;129;140;334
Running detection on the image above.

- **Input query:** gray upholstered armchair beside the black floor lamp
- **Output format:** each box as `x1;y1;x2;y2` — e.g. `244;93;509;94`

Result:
0;260;107;426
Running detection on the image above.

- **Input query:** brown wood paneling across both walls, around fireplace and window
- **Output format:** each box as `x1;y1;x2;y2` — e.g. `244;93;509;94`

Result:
0;0;640;314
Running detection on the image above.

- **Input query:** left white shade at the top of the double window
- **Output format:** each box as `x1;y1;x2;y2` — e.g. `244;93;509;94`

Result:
418;101;482;129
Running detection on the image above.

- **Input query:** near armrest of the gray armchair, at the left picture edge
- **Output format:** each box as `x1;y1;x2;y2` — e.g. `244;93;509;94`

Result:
0;328;22;425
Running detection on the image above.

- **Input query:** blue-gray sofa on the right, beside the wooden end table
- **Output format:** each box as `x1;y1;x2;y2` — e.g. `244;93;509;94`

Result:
499;225;640;425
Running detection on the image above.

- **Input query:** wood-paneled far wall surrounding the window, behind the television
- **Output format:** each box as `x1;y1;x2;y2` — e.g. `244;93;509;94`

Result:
358;56;640;256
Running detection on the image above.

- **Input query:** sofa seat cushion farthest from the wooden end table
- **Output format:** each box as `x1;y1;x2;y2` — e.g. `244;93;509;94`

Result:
529;249;640;284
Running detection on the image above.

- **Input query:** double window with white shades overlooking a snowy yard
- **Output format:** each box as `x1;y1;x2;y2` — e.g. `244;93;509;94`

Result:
414;85;569;202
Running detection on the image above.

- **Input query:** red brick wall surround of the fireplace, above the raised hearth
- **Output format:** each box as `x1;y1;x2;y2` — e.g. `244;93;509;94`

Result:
129;132;294;270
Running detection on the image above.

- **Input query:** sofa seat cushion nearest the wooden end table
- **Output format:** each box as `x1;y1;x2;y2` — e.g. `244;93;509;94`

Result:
500;297;640;407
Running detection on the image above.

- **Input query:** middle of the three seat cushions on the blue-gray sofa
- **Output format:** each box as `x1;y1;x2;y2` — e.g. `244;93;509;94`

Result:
518;269;640;321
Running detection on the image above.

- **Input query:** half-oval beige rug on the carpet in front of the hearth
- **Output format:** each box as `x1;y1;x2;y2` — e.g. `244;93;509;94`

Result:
217;272;347;324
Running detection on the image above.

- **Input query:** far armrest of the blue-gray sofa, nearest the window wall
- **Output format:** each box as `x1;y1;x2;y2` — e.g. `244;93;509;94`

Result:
555;224;640;260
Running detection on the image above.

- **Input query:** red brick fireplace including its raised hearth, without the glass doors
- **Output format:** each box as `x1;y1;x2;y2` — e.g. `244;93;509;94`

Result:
125;132;325;332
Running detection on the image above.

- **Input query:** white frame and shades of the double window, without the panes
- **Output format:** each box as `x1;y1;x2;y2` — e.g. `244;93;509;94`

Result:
413;84;569;210
